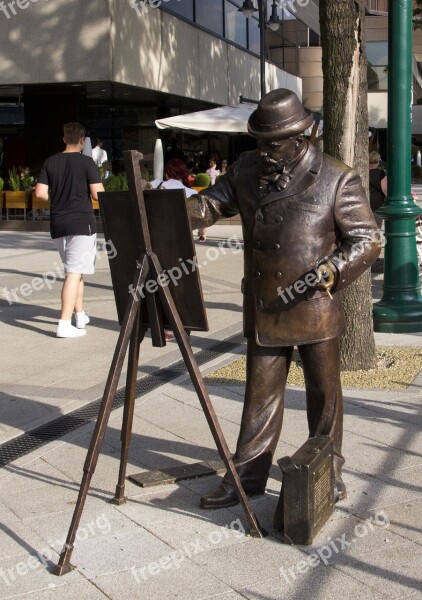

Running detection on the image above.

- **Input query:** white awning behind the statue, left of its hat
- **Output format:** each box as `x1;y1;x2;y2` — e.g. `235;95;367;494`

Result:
155;103;256;133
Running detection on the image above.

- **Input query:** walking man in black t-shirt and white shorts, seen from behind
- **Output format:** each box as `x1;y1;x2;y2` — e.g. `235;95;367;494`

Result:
35;123;104;338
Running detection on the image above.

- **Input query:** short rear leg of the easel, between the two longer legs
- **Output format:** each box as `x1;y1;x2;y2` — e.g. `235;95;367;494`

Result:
111;310;145;505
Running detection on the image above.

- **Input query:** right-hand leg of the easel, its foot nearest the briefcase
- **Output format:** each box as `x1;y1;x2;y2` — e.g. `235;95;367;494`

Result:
150;254;264;537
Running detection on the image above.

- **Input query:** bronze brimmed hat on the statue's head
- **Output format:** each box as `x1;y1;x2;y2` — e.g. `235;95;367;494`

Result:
248;88;314;139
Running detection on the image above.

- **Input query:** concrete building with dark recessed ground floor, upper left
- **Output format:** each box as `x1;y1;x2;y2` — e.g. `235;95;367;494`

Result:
0;0;301;175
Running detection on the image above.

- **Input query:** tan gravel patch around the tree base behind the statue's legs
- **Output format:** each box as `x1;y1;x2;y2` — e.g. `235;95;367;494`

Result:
206;346;422;389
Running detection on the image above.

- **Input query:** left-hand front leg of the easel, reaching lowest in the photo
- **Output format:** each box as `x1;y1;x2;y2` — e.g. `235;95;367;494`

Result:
54;255;149;575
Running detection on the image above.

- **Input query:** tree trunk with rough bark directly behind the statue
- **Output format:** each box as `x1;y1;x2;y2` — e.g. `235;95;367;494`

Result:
319;0;376;371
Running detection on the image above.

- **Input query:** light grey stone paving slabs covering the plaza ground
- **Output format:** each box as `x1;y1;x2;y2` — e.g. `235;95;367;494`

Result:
0;225;422;600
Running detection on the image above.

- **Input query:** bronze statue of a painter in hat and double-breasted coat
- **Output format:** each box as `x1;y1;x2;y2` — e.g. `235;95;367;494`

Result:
187;89;380;520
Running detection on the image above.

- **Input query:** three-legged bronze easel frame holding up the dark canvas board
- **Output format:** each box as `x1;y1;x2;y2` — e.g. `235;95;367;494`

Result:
54;151;263;575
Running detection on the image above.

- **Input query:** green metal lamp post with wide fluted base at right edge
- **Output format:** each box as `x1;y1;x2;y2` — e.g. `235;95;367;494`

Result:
373;0;422;333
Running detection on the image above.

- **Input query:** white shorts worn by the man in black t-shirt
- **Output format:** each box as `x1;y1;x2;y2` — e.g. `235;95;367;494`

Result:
54;233;97;275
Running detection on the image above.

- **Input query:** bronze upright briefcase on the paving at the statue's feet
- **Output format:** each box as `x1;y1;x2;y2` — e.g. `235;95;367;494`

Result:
277;436;334;545
